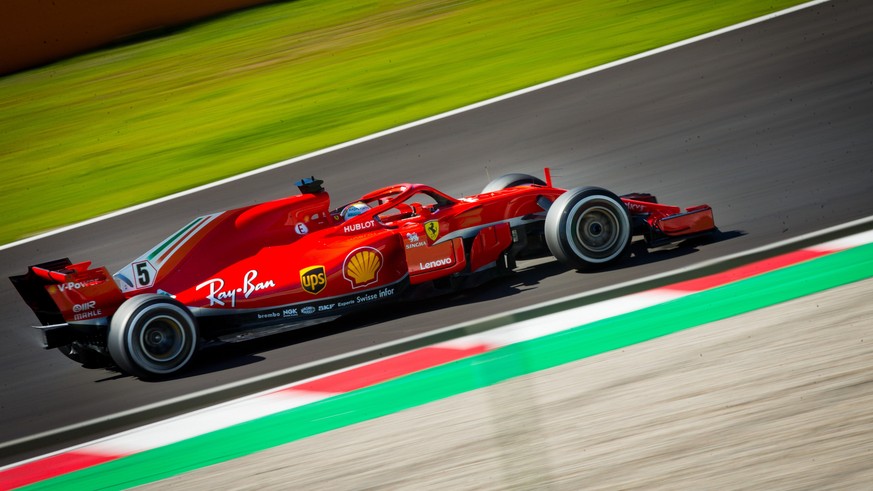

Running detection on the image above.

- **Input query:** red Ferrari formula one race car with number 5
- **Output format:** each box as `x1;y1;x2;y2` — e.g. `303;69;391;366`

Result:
11;173;715;378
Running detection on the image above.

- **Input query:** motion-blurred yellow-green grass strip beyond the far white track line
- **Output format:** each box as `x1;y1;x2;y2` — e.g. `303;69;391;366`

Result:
0;0;802;243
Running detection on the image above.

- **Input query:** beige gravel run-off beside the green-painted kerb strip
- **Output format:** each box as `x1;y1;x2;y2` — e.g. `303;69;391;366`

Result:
145;280;873;490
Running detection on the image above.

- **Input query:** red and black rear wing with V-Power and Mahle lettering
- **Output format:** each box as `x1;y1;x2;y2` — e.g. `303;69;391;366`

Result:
9;258;125;326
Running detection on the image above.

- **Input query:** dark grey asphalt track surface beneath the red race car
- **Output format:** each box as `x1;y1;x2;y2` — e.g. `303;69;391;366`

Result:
0;0;873;465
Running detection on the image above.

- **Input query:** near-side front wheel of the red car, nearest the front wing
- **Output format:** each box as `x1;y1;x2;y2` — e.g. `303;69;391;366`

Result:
545;187;633;271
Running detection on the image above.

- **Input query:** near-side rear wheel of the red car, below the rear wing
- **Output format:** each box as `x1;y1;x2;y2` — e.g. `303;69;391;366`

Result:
107;294;197;379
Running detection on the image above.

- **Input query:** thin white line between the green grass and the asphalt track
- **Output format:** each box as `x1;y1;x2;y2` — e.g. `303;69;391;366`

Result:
0;0;831;251
